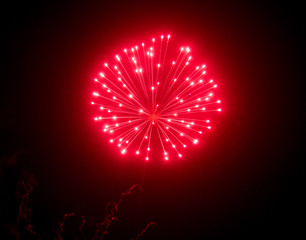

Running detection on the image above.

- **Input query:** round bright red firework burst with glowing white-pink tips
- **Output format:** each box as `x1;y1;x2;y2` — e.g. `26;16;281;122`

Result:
91;35;221;160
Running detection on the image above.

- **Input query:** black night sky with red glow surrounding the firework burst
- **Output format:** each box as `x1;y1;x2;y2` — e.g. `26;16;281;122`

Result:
0;1;305;239
